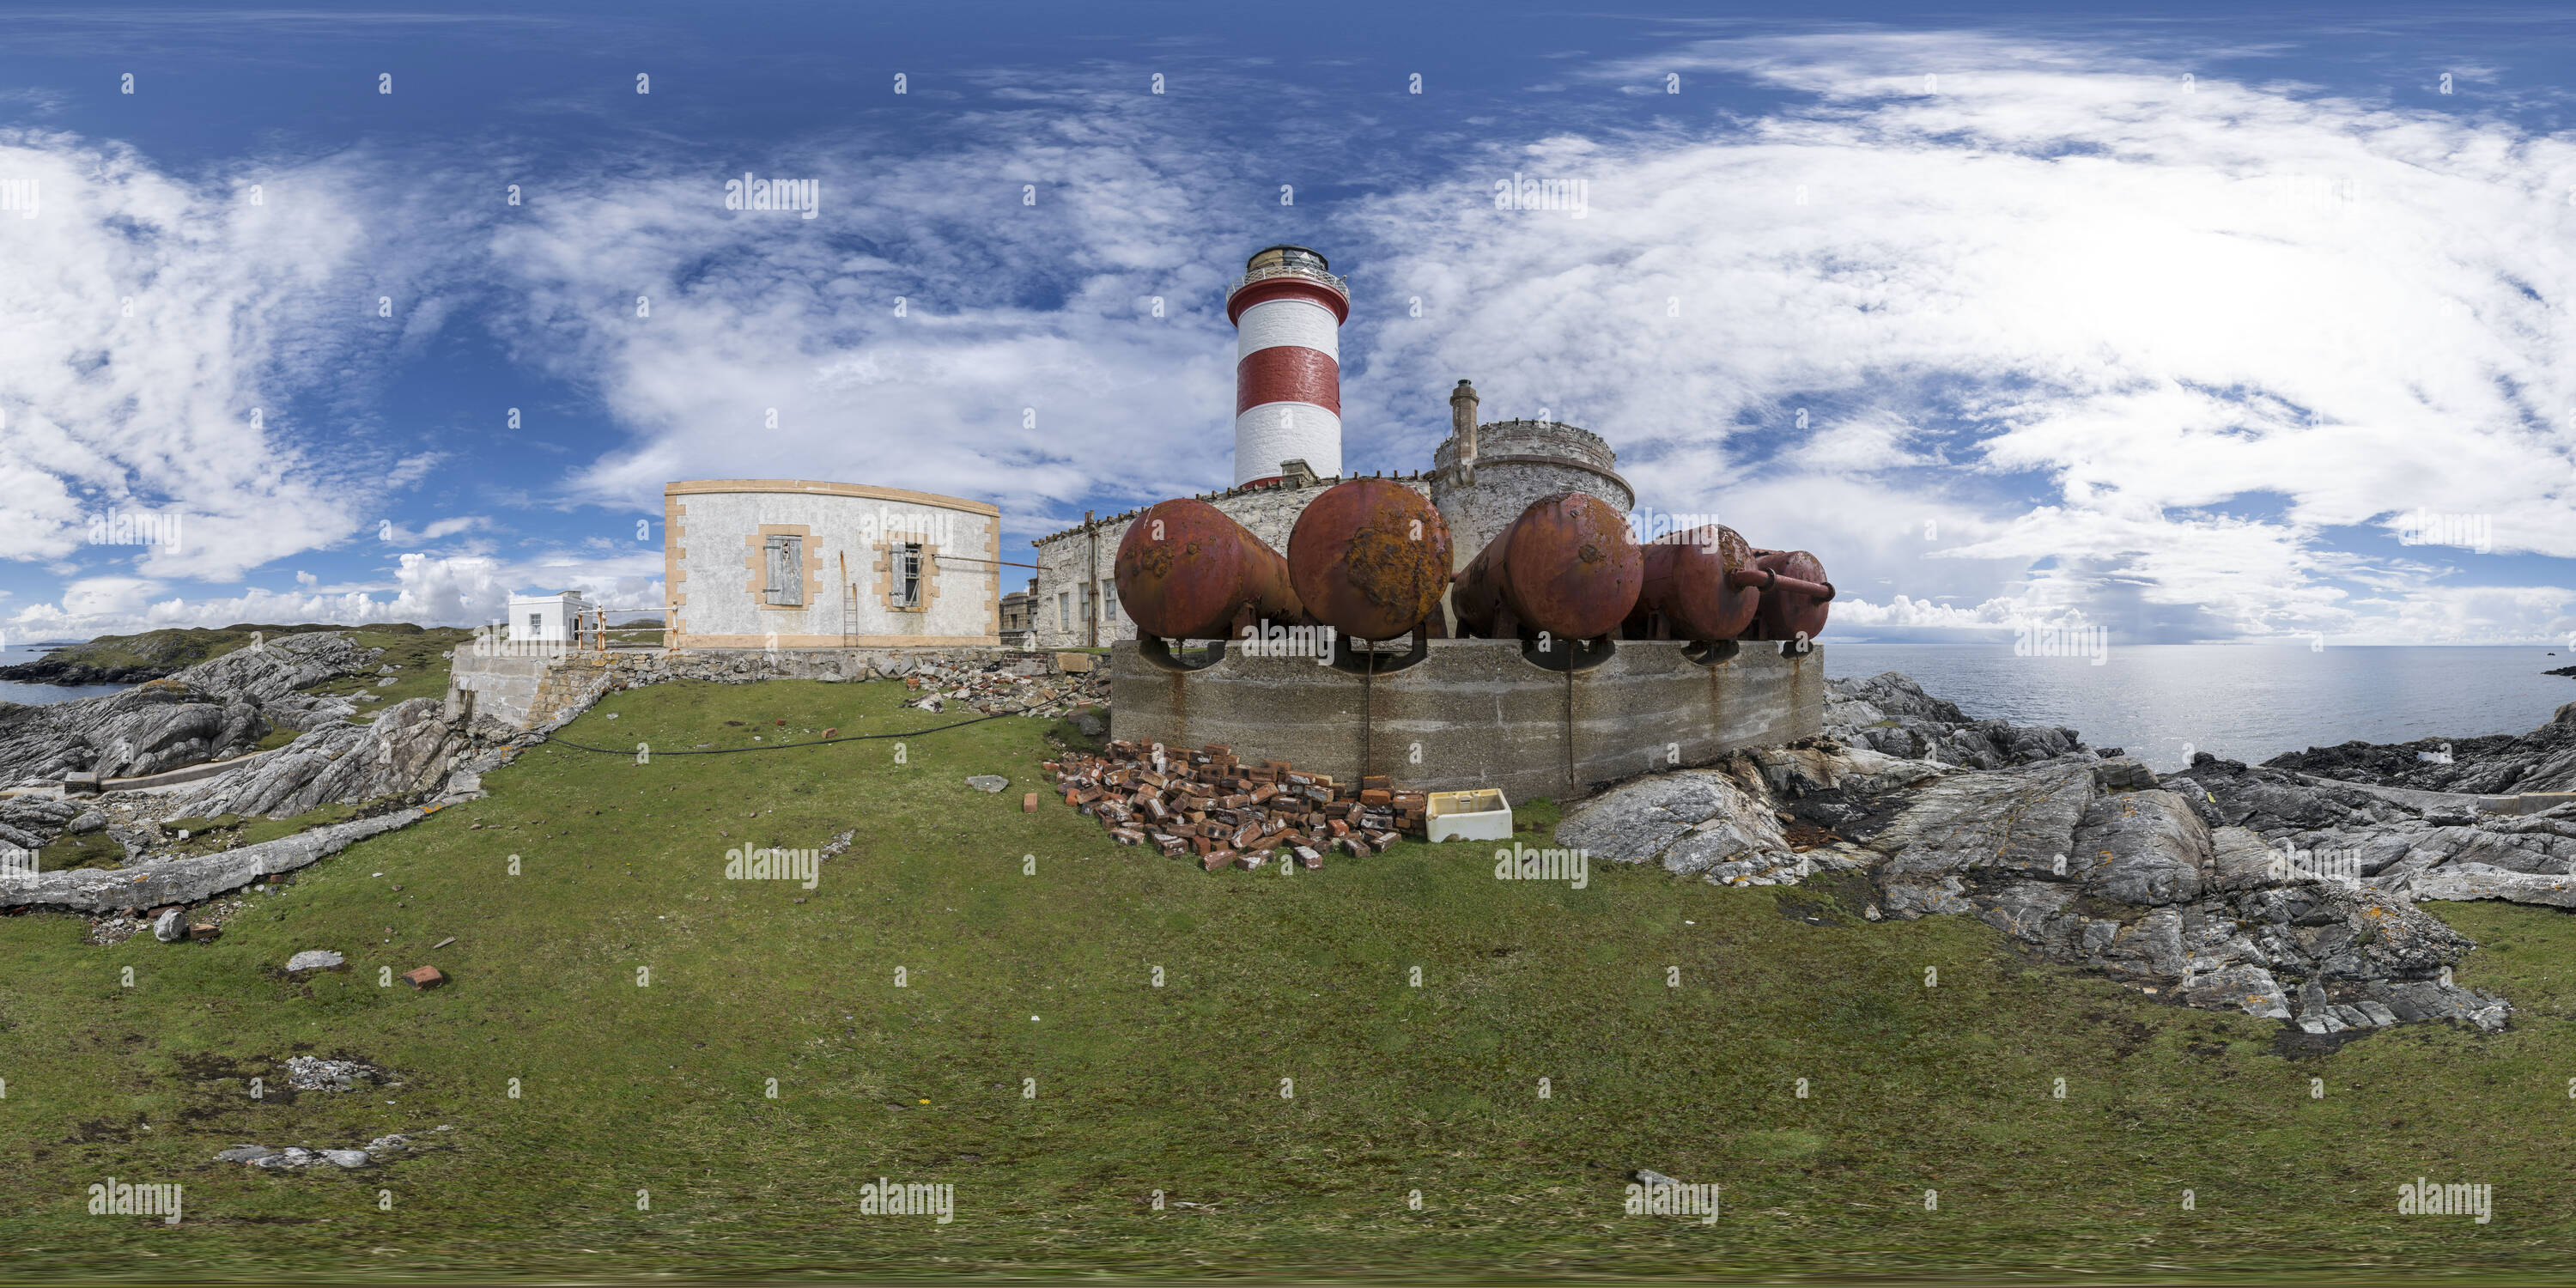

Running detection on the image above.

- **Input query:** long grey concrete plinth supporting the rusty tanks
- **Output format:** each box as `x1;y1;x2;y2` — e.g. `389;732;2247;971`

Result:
1110;639;1824;801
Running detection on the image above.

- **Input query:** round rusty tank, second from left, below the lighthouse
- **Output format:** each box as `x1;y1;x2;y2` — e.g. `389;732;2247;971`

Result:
1288;479;1450;639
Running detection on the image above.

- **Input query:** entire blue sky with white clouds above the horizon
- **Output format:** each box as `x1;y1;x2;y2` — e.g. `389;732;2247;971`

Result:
0;3;2576;644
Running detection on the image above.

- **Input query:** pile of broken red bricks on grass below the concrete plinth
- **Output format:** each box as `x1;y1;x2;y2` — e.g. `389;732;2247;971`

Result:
1046;742;1425;873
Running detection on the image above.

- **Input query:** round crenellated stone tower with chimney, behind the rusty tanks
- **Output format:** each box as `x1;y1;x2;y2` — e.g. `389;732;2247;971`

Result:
1432;381;1636;569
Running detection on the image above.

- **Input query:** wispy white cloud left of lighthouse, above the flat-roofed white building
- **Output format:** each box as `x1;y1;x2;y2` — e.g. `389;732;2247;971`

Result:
492;106;1257;523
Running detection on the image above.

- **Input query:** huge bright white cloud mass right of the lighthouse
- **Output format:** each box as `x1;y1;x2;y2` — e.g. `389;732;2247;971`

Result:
1368;36;2576;639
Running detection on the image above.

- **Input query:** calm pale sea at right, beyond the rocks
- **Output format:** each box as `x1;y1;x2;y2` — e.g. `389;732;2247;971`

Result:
1819;649;2576;773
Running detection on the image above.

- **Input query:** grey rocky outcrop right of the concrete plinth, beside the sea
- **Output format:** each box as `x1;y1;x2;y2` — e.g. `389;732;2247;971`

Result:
1556;672;2524;1033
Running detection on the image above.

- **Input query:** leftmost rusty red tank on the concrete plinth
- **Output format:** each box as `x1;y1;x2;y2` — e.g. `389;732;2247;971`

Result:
1115;497;1303;639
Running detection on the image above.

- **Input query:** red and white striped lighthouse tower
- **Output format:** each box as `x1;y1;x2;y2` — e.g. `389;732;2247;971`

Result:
1226;245;1350;487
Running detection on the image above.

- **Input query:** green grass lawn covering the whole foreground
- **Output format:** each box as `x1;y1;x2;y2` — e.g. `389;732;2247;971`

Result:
0;680;2576;1283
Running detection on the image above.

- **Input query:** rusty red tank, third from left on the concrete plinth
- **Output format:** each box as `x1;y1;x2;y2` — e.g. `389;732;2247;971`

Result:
1450;492;1646;639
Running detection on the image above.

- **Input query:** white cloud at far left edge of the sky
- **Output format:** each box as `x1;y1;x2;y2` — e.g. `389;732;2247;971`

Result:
0;131;422;580
